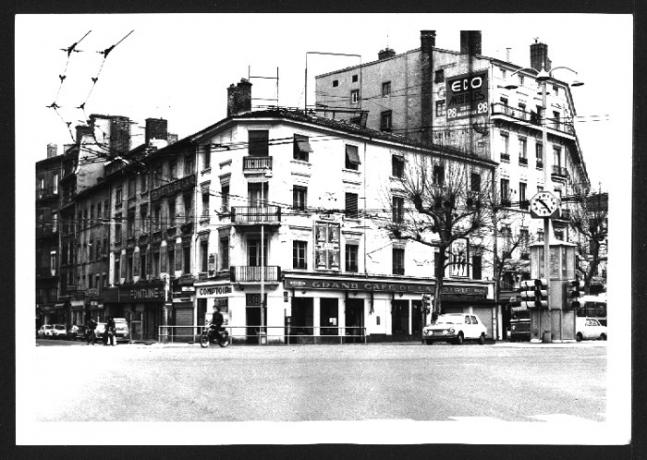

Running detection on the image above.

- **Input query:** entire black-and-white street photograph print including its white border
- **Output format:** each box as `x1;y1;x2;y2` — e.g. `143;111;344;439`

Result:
15;13;634;446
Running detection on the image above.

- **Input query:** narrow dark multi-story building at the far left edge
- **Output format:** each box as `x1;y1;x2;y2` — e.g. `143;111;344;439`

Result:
35;144;65;328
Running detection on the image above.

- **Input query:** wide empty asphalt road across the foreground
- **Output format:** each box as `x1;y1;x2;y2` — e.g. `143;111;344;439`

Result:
33;340;606;421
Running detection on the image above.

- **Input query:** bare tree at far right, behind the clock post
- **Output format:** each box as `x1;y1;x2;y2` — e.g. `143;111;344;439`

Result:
569;191;609;294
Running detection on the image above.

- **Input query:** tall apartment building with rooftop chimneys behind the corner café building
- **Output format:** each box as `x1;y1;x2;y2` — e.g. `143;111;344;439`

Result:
315;30;590;289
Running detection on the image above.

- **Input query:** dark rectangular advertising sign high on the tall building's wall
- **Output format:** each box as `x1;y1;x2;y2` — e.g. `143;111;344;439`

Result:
446;71;489;121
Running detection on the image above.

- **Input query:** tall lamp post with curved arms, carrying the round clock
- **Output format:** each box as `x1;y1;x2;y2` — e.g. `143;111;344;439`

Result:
504;66;584;340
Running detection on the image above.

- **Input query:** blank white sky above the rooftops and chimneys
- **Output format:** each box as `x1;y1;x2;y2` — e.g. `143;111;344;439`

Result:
16;14;632;188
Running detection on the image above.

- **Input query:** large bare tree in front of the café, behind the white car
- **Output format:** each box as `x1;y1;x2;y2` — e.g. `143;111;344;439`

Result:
384;156;492;315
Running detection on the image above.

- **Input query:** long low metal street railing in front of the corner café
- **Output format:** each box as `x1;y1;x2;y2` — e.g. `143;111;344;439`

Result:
157;325;367;345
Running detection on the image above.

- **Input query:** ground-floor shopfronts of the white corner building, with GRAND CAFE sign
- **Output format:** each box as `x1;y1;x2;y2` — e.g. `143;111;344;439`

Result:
192;273;500;343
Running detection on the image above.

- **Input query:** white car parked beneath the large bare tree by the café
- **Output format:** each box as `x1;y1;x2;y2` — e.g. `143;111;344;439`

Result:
422;313;487;345
